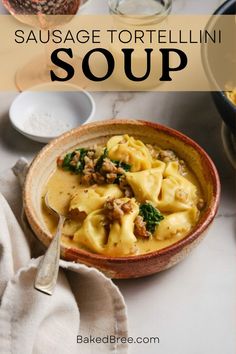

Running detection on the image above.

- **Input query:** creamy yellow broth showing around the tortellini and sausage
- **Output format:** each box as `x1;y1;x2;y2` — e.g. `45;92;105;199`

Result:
42;137;202;257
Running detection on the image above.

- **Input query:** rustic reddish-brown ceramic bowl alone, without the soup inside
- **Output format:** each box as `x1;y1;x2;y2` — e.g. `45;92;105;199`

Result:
24;120;220;279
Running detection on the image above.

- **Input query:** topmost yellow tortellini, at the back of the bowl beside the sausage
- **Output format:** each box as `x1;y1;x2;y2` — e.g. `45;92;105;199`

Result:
107;135;152;172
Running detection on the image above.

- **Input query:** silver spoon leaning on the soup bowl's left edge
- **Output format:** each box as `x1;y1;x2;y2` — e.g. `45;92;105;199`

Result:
34;193;66;295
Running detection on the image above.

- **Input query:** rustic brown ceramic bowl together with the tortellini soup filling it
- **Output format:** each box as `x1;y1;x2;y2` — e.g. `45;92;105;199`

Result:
24;120;220;278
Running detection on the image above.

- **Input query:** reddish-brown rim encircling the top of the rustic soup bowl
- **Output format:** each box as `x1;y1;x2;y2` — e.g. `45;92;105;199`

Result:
23;119;221;264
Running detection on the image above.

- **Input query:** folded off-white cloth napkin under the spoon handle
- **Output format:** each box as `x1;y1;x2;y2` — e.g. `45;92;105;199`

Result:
0;160;128;354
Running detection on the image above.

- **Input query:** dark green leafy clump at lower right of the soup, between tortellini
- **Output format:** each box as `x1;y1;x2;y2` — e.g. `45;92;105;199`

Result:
139;203;164;233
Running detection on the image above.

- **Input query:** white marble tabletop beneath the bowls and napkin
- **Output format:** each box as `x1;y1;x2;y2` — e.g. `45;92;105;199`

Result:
0;0;236;354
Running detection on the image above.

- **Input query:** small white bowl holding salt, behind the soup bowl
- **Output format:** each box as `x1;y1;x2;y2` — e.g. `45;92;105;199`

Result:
9;83;95;143
